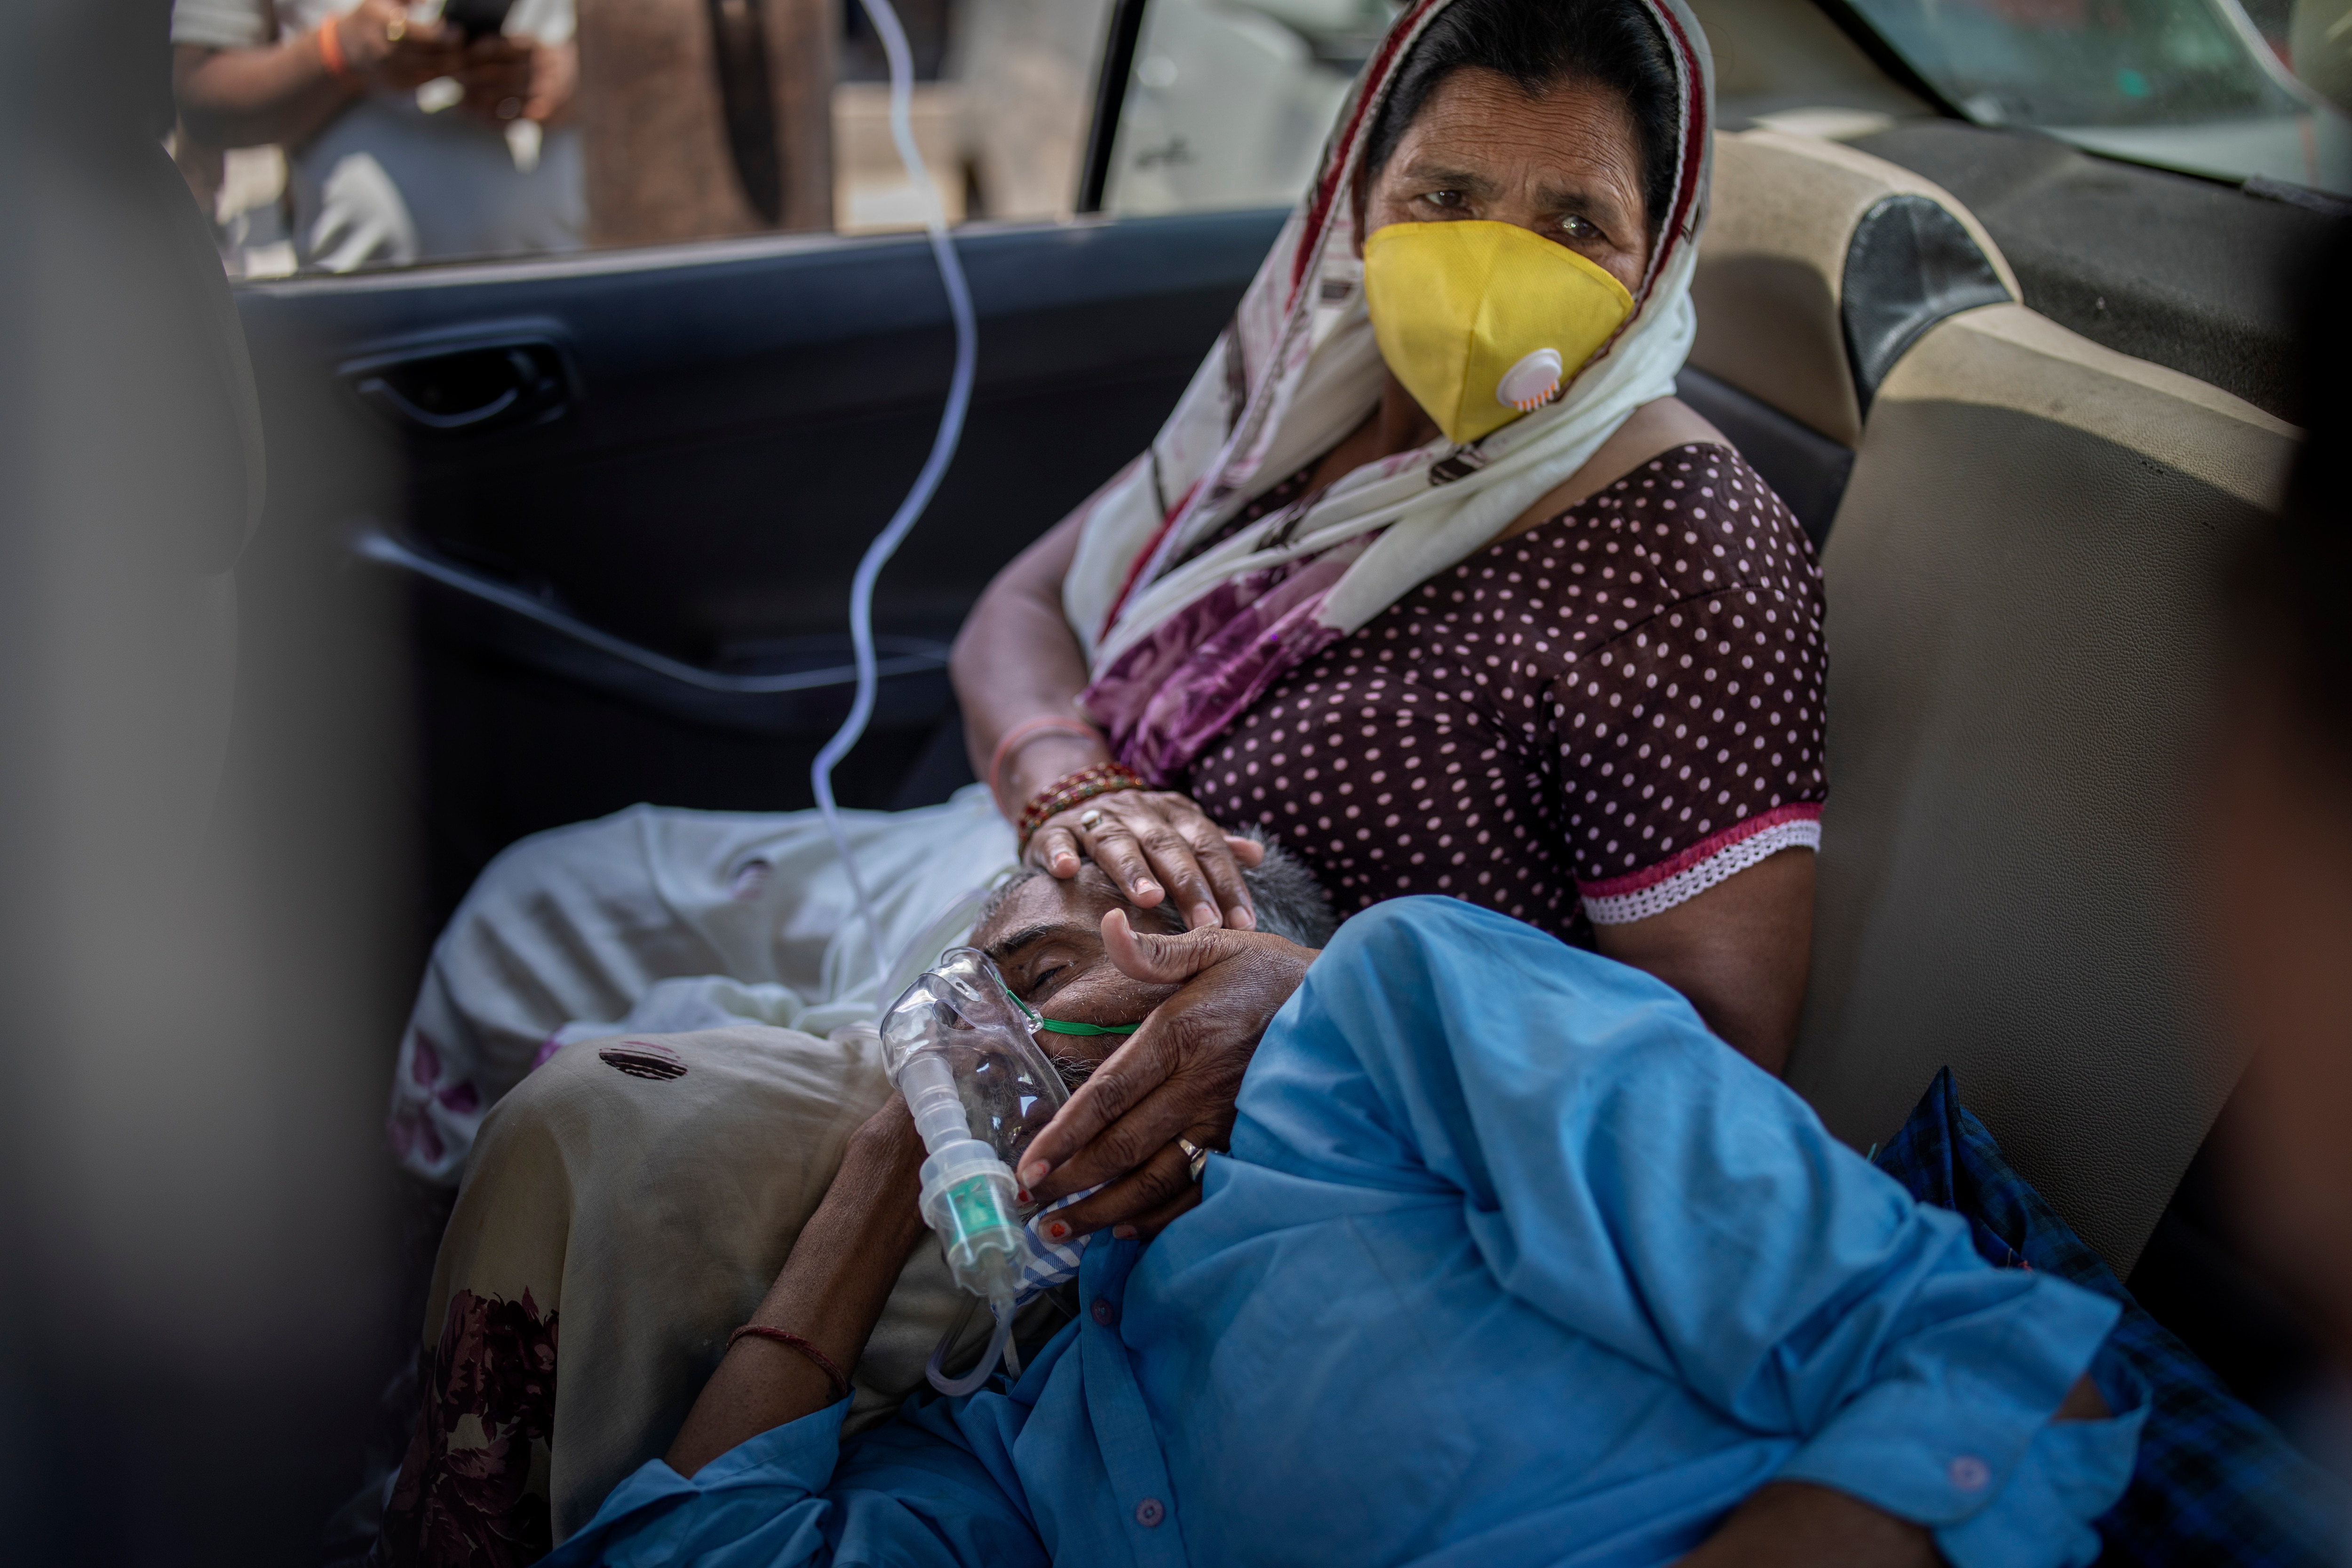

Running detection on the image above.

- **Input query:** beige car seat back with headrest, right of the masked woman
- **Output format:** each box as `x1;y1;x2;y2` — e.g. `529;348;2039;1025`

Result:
1691;132;2293;1274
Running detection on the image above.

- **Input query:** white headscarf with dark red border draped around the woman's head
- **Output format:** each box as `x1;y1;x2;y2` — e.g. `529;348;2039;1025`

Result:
1063;0;1715;673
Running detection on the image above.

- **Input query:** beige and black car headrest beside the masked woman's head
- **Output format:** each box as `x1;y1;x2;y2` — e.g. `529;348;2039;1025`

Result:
1691;132;2023;447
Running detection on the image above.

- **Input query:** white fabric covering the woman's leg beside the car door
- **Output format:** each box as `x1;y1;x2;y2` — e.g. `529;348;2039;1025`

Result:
390;785;1014;1185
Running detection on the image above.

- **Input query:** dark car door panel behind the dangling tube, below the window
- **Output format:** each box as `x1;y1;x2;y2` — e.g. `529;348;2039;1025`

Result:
240;212;1282;917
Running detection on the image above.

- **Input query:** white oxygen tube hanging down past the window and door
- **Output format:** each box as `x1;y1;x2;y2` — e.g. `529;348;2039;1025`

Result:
809;0;981;1006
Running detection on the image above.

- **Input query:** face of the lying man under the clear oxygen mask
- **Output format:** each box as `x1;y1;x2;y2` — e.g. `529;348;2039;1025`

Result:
971;860;1183;1067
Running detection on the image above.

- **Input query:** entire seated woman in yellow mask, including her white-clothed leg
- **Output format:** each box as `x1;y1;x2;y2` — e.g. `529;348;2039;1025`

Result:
393;0;1825;1279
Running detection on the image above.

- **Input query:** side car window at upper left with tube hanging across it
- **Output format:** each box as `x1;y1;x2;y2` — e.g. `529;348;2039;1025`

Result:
172;0;1110;277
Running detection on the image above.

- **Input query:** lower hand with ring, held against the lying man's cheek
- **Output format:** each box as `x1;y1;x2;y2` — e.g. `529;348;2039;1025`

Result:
1018;910;1315;1241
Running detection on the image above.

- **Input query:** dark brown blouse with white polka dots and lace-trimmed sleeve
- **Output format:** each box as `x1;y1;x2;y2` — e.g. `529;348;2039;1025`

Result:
1190;444;1828;938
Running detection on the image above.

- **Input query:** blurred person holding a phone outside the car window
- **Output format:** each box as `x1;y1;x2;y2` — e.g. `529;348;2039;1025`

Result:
172;0;586;273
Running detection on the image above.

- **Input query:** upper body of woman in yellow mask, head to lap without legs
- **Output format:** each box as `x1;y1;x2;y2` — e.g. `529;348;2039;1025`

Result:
957;0;1823;1067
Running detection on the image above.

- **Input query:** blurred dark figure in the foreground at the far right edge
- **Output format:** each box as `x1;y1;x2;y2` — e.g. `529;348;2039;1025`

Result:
2206;223;2352;1368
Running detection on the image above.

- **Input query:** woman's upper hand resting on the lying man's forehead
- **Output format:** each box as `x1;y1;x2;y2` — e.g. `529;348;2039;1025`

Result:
1028;790;1265;931
